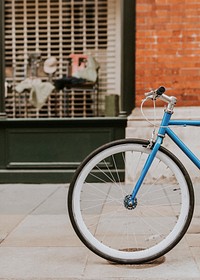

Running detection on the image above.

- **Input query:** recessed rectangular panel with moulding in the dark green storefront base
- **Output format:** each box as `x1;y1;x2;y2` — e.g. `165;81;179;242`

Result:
7;128;113;168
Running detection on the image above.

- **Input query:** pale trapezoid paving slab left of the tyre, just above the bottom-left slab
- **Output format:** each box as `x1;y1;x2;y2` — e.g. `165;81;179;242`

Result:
2;214;81;247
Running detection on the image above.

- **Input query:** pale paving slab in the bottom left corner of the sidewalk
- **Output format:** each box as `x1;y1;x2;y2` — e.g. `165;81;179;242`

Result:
0;247;86;279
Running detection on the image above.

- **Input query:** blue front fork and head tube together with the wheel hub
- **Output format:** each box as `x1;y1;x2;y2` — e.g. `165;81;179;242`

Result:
124;112;172;209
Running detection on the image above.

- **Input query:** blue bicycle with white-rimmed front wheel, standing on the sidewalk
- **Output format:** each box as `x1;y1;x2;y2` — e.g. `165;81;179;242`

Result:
68;87;197;264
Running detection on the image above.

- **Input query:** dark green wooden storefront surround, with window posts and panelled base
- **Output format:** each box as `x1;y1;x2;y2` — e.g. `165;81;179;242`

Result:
0;0;135;183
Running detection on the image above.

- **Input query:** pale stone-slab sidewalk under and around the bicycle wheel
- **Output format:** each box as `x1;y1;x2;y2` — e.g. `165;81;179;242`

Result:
0;184;200;280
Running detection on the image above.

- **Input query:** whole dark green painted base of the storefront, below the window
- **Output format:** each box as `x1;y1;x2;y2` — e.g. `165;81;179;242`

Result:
0;118;127;183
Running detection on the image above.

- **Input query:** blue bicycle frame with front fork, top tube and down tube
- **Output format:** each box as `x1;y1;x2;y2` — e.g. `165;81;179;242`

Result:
131;112;200;203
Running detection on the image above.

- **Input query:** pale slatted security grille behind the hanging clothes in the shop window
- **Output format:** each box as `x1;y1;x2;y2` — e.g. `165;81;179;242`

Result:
5;0;119;118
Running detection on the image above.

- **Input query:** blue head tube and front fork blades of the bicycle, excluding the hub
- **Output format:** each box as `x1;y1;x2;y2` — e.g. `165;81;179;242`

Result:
131;112;171;201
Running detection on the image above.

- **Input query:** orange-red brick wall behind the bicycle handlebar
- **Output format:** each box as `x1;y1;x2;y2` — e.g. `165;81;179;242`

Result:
136;0;200;106
